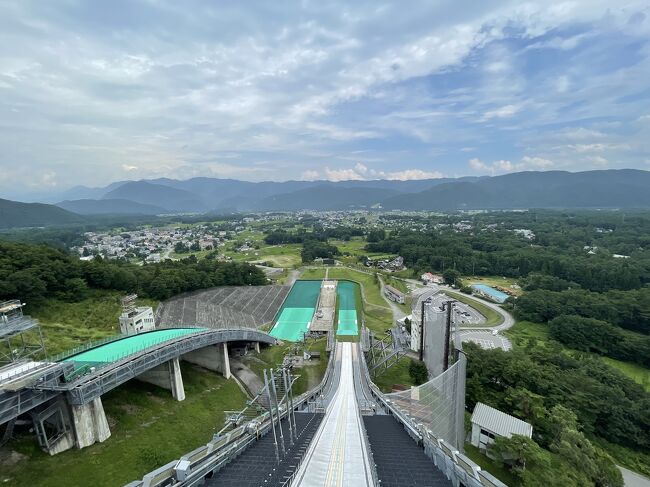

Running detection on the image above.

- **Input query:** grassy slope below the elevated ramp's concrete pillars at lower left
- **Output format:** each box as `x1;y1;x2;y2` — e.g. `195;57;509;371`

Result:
0;362;246;487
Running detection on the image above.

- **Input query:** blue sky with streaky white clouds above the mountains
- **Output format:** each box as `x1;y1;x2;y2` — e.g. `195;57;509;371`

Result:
0;0;650;197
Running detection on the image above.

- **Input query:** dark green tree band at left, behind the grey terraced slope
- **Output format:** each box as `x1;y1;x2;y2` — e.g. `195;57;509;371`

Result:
0;241;267;304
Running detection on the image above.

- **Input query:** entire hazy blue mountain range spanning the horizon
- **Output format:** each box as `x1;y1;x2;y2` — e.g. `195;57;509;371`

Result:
0;169;650;228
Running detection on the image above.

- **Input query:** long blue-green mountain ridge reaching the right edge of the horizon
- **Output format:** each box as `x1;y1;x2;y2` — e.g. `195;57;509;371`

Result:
383;169;650;210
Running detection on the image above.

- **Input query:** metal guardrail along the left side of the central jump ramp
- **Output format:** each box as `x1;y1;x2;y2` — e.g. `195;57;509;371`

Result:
125;336;336;487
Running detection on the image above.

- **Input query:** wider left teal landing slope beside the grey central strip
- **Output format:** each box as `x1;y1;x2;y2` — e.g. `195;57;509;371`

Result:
271;281;321;342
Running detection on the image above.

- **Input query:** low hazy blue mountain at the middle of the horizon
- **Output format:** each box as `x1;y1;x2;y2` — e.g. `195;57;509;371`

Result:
254;185;398;211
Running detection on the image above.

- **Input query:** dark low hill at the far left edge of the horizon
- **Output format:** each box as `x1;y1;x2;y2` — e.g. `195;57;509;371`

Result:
0;199;84;228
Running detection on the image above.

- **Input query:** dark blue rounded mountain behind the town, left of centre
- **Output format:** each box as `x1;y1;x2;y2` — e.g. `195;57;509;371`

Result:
102;181;210;213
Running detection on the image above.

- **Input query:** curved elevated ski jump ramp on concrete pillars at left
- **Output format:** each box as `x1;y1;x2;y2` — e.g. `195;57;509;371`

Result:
0;328;276;454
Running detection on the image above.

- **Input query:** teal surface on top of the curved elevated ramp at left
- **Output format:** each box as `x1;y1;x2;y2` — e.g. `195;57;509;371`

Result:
63;328;206;369
